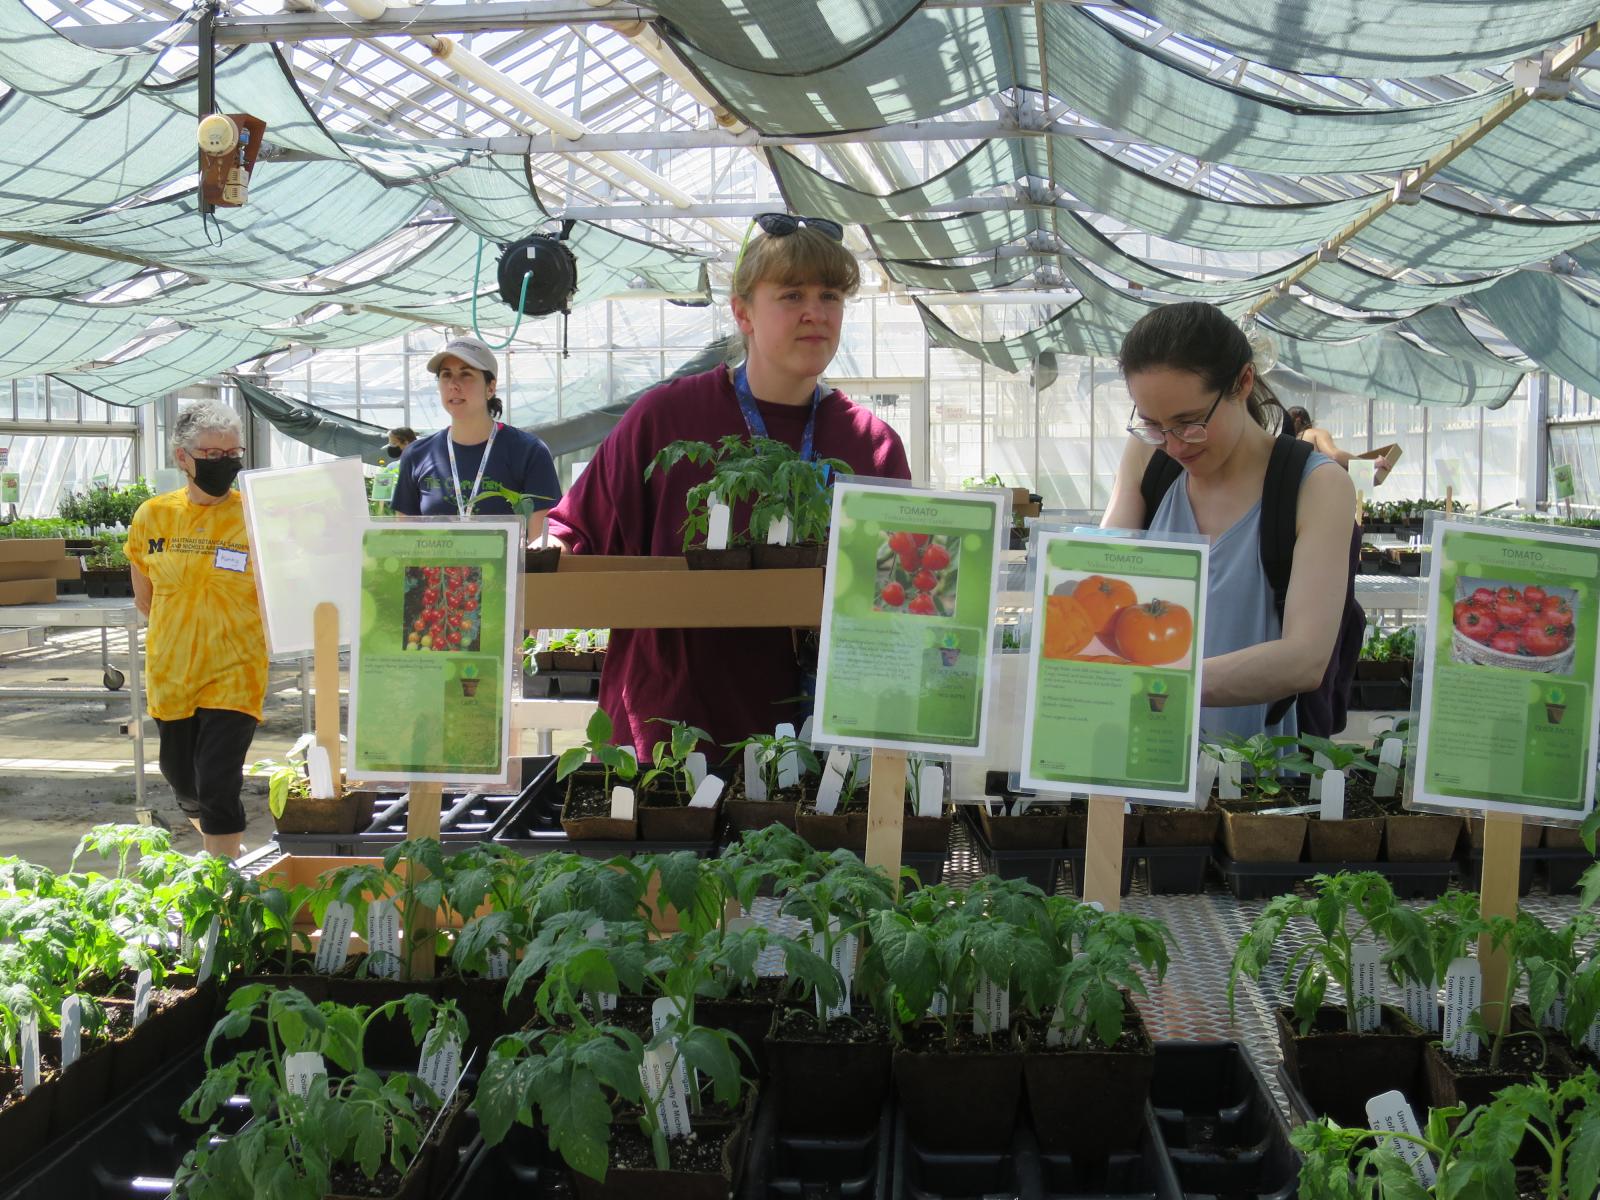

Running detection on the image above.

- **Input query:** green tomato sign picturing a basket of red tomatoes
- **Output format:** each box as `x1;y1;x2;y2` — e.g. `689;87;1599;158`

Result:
1413;522;1600;819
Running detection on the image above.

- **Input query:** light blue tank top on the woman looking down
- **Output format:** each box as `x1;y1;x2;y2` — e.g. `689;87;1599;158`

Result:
1150;451;1333;741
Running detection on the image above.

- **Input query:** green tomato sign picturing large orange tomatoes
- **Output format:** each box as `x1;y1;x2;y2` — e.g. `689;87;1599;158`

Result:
1019;531;1208;805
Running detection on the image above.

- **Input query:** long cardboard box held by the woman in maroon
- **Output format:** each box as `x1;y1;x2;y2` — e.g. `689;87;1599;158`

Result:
523;555;824;629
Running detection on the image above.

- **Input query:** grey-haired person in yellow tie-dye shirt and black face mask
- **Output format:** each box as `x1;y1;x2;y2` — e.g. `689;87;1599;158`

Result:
125;400;267;858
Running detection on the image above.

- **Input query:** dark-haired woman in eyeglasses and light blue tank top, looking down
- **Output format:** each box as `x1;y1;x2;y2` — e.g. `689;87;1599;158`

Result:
1101;302;1355;738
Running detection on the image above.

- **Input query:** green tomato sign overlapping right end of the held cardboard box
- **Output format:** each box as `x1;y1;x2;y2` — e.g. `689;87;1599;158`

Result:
813;480;1011;754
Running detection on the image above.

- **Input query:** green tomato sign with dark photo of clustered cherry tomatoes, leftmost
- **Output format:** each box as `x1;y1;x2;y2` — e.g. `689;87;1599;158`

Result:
350;522;522;782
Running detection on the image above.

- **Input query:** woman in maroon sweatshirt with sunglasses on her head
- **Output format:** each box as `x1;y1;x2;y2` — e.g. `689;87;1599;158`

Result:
550;213;910;758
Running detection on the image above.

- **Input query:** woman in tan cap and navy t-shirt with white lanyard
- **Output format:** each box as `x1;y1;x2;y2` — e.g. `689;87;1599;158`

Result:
394;338;562;539
